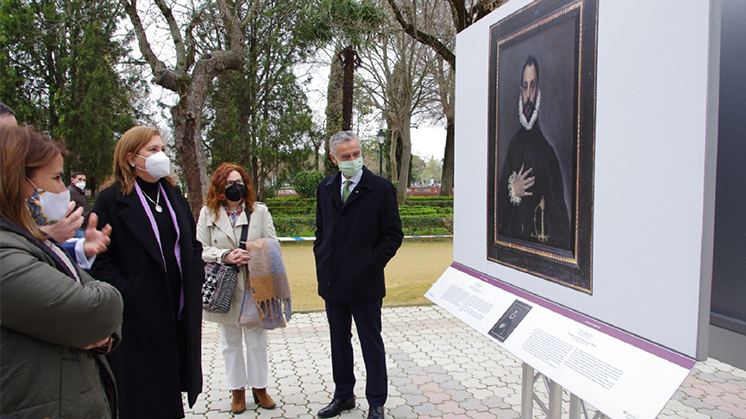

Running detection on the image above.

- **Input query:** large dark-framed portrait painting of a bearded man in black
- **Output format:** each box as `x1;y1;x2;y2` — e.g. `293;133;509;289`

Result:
487;0;597;294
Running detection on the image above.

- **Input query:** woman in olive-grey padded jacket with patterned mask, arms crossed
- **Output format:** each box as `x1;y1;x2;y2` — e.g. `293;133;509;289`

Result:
0;126;123;419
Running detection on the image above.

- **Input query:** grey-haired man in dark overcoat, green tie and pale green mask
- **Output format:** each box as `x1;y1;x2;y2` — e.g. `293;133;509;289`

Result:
313;131;404;419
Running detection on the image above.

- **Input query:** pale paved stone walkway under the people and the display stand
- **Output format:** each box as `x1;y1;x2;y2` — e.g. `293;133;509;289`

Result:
186;306;746;419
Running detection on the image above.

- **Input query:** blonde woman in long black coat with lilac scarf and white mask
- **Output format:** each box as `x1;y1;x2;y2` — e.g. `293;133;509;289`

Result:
92;126;204;419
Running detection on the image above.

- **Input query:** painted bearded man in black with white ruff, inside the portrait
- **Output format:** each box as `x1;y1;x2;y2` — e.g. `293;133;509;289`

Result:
497;56;571;250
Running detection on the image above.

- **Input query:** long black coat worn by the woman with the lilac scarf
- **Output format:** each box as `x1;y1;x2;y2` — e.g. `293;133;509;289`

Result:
91;181;204;419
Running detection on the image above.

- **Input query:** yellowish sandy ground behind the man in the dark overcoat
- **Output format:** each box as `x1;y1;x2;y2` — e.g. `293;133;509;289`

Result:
281;239;453;311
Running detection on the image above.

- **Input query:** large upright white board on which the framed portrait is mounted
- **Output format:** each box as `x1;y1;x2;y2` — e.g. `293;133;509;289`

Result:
454;0;719;359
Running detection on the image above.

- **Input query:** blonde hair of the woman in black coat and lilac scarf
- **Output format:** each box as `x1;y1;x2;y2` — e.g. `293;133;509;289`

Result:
103;125;176;195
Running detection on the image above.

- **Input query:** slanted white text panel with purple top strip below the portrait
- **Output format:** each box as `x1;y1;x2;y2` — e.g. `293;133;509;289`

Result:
425;264;694;419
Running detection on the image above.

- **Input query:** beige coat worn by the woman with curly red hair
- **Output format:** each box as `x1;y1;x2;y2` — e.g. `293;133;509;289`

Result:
197;202;277;326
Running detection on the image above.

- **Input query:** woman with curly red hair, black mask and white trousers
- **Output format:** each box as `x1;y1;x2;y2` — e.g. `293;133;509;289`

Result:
197;163;277;413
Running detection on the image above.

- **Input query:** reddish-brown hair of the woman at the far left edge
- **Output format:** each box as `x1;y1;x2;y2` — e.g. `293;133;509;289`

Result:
0;125;67;240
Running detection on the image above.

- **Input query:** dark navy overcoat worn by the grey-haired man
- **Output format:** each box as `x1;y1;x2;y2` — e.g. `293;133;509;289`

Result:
313;167;404;303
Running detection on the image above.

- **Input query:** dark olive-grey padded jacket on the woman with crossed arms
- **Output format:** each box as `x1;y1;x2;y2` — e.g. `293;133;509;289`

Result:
0;220;123;419
